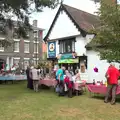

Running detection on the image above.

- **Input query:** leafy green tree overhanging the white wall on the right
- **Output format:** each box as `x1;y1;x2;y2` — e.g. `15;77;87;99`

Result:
90;0;120;62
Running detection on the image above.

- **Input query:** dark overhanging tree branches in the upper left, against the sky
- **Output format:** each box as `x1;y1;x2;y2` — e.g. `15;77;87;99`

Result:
0;0;59;46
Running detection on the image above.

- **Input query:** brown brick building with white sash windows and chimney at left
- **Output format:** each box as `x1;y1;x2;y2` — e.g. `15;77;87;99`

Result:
0;20;43;70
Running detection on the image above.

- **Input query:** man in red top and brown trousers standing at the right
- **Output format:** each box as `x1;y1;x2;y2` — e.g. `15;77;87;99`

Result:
104;63;119;105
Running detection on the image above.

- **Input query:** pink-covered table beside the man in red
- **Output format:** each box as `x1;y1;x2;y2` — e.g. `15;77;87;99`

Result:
87;85;120;95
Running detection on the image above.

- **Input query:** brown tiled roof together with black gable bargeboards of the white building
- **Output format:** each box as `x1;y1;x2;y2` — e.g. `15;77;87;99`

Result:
44;4;100;41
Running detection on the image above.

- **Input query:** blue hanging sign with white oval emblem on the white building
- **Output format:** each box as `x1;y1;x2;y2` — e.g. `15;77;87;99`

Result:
48;41;56;58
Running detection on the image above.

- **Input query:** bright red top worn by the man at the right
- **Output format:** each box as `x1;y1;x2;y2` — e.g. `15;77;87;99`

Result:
107;66;120;84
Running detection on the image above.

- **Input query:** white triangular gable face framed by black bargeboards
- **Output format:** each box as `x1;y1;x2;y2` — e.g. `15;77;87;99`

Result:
49;11;80;39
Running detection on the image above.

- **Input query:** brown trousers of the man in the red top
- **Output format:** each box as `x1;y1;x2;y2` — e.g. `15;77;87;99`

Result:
105;84;117;102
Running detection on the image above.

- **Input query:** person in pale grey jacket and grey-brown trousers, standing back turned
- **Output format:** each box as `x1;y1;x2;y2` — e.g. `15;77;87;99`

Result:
31;67;39;92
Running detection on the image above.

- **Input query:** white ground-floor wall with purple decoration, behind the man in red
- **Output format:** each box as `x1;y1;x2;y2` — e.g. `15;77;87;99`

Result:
87;50;109;83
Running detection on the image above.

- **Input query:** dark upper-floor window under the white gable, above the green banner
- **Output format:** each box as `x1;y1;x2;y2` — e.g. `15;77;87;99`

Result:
59;39;75;53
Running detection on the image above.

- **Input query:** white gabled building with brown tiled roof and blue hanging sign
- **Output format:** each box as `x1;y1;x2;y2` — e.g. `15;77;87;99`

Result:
44;5;118;83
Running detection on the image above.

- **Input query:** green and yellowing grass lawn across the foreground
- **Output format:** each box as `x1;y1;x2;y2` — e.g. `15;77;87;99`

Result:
0;83;120;120
